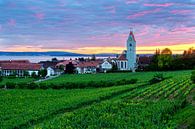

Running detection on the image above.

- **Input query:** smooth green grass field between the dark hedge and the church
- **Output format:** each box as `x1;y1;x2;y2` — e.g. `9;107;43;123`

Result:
41;71;191;84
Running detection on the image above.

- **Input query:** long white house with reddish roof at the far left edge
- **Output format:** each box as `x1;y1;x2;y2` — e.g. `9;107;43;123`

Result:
0;60;41;76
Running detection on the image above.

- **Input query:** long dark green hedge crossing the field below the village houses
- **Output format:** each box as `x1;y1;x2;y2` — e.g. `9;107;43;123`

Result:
3;79;138;89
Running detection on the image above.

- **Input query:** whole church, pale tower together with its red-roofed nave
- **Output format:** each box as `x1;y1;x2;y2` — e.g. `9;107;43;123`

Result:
116;31;137;72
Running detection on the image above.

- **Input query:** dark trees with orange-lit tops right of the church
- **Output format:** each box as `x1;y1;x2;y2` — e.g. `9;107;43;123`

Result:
142;48;195;71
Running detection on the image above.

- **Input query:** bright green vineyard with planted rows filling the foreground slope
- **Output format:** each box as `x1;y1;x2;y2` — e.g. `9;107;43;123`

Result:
0;71;195;129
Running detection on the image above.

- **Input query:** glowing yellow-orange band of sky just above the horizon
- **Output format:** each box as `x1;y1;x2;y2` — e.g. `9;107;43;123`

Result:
1;42;195;54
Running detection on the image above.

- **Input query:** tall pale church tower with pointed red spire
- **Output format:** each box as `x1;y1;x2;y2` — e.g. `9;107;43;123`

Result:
126;30;137;72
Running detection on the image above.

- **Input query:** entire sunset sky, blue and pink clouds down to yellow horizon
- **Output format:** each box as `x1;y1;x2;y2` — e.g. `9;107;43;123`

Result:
0;0;195;54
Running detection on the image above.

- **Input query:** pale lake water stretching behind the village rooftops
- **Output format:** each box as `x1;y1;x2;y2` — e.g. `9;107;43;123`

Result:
0;56;110;63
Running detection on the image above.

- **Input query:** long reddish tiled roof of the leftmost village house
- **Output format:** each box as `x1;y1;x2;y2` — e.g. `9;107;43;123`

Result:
0;63;41;70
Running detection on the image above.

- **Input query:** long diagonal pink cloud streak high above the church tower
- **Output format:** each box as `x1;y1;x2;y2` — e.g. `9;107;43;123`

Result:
127;8;161;19
